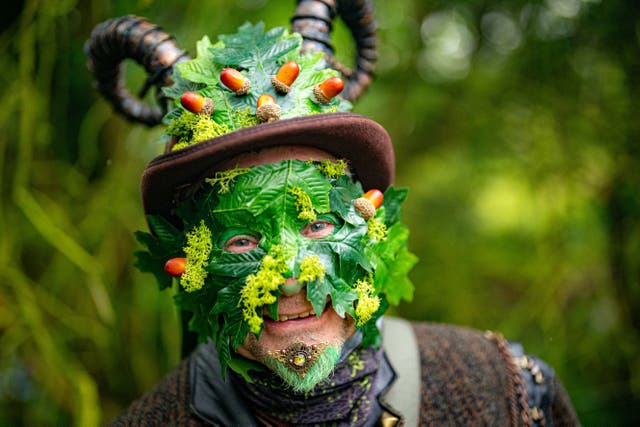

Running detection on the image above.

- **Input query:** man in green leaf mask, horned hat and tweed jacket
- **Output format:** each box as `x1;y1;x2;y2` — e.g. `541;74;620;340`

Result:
88;2;578;426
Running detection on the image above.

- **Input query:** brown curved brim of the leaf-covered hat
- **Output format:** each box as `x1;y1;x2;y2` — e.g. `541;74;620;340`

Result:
142;113;395;217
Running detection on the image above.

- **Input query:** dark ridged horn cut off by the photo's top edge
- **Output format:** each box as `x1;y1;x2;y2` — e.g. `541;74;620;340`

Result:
291;0;378;101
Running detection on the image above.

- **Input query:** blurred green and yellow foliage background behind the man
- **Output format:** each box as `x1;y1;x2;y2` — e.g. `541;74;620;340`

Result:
0;0;640;426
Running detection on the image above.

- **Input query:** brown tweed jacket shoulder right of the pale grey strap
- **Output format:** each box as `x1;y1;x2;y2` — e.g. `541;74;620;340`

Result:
412;322;579;425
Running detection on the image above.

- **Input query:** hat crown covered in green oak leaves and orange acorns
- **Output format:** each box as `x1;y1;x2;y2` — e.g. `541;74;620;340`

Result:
163;23;351;150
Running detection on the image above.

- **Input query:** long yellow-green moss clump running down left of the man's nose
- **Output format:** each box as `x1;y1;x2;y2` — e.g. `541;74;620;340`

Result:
238;246;289;334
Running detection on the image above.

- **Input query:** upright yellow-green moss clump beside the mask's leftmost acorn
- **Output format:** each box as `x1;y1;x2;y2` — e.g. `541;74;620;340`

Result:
180;221;212;292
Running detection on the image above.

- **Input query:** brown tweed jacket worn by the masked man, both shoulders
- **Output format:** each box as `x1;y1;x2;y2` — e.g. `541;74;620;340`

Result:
112;322;579;426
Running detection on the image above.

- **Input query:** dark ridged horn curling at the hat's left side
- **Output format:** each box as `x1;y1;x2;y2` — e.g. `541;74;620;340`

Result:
85;16;189;126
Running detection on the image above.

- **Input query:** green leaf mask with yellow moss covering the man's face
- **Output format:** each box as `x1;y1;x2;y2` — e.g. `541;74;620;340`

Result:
138;160;416;371
